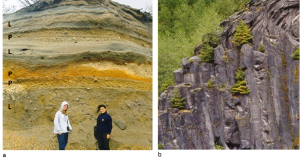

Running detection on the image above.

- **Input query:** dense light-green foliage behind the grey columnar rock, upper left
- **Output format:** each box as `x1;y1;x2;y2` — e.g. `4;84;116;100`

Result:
158;0;250;94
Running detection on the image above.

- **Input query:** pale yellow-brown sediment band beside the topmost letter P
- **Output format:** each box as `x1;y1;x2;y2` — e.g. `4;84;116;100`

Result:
3;28;152;48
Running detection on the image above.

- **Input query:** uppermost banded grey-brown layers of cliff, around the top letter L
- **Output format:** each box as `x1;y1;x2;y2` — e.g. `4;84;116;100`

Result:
3;1;152;43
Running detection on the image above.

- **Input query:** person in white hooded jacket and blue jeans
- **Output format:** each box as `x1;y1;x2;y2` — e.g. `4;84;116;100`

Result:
54;101;72;150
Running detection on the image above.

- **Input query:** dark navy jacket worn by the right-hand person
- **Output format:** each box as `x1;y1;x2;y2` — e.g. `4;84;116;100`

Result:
97;112;112;134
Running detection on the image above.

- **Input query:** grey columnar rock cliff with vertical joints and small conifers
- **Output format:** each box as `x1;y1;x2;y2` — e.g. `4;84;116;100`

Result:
158;0;299;149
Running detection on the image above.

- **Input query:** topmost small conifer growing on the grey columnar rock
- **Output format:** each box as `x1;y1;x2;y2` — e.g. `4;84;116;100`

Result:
232;20;252;47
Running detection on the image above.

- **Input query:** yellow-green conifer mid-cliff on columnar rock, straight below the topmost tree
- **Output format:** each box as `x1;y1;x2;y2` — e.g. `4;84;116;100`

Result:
230;68;251;95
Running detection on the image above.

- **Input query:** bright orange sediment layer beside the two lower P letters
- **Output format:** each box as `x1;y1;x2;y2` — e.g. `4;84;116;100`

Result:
3;61;152;91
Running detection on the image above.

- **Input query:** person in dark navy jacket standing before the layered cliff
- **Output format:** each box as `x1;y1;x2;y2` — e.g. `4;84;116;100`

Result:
97;105;112;150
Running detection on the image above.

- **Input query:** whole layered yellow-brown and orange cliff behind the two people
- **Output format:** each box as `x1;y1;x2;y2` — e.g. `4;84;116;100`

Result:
3;0;152;150
